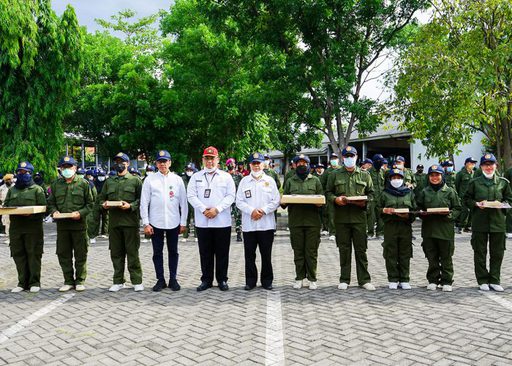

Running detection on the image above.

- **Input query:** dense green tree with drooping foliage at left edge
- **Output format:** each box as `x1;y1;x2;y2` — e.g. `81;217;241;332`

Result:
0;0;83;177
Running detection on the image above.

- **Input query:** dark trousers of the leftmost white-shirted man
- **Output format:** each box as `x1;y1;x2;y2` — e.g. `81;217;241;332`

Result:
151;226;180;281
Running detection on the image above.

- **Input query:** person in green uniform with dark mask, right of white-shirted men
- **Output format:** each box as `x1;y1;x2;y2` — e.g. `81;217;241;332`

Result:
282;154;323;290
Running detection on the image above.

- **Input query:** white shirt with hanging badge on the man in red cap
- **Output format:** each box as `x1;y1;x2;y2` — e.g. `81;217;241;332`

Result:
187;169;236;228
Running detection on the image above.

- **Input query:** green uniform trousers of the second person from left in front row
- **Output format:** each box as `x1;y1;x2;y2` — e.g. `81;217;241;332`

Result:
56;230;89;286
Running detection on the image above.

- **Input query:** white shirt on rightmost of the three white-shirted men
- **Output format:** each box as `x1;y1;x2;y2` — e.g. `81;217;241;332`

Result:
236;174;281;232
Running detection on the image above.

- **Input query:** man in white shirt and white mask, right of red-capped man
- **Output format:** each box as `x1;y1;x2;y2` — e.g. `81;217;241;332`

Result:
236;153;280;291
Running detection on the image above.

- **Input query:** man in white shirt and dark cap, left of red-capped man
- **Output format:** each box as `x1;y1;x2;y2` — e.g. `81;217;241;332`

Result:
140;150;188;291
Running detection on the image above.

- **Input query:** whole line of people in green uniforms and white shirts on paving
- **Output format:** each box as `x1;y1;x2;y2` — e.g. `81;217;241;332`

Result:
3;146;512;292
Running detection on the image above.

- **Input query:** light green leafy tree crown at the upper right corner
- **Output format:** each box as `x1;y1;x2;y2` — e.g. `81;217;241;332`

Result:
395;0;512;167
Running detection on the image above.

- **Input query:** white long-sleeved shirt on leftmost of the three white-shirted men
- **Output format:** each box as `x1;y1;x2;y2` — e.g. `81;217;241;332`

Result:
140;172;188;229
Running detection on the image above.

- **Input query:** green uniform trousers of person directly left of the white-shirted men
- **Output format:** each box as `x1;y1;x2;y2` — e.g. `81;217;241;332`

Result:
109;226;142;285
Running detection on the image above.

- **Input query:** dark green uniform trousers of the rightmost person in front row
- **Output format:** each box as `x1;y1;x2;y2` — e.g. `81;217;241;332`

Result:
471;231;506;285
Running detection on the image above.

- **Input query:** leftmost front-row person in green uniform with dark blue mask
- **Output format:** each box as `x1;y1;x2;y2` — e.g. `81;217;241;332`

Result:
4;161;46;292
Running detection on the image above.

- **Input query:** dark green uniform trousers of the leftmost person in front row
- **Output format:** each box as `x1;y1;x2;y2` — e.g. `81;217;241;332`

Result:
9;229;44;290
